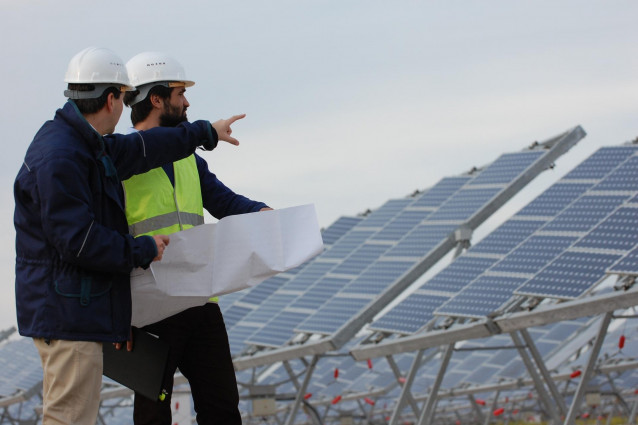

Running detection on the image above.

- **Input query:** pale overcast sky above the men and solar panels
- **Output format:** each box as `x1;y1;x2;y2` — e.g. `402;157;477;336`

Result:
0;0;638;329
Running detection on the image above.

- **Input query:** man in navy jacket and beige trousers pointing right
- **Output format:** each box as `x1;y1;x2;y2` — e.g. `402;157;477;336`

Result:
14;47;245;424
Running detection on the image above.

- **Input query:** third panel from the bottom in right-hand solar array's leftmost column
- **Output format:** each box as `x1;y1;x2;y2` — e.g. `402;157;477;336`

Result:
469;220;545;255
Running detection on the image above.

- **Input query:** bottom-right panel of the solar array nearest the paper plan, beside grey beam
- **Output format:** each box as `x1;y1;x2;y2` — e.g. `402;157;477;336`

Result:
295;297;370;335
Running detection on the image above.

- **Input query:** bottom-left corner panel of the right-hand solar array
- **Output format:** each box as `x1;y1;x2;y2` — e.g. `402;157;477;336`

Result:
370;293;449;334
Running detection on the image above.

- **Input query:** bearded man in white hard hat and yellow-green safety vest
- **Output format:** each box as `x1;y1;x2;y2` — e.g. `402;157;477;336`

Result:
123;52;270;425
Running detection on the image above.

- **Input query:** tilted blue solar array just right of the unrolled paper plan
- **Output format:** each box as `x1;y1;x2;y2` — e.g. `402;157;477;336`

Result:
230;137;580;347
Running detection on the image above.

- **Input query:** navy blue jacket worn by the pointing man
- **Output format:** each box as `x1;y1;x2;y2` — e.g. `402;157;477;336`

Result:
14;101;217;342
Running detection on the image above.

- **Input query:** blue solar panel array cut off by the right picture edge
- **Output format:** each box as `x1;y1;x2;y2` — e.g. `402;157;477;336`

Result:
370;146;638;334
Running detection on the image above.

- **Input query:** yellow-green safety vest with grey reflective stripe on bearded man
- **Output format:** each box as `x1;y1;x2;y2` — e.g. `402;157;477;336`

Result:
123;155;204;236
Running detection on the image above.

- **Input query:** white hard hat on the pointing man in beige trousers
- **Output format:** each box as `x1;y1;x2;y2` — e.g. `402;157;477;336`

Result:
64;47;135;99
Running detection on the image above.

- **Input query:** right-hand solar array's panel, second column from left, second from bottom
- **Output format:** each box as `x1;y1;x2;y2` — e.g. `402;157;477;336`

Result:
490;236;577;273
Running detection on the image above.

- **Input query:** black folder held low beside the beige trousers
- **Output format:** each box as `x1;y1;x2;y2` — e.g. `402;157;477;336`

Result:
102;328;169;401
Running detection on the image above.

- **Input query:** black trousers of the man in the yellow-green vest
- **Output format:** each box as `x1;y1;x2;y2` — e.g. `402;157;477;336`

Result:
133;303;241;425
